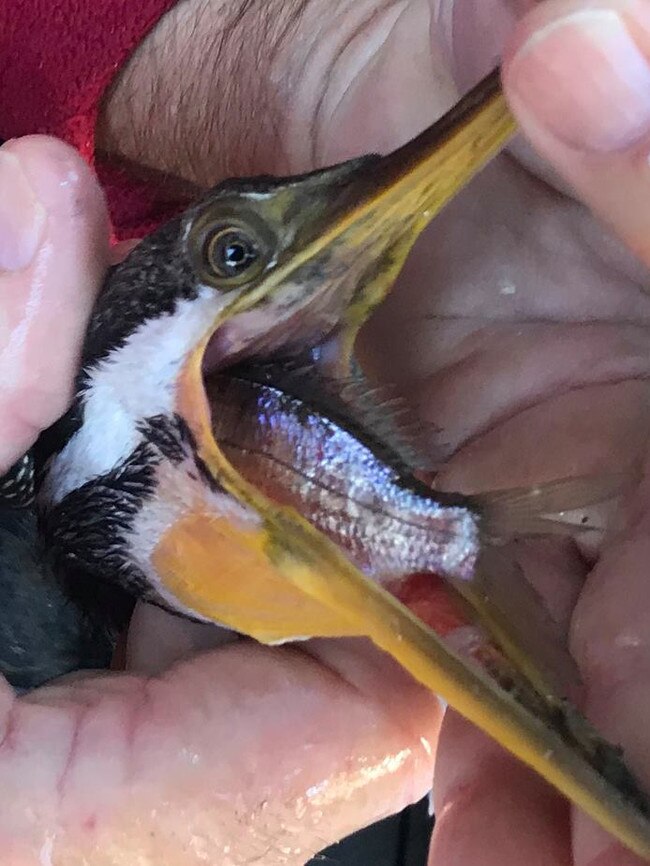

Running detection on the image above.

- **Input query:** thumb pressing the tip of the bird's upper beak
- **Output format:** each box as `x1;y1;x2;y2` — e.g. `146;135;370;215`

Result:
504;0;650;264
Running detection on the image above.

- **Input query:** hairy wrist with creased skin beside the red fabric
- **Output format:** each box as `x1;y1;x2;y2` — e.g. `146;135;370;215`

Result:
97;0;438;186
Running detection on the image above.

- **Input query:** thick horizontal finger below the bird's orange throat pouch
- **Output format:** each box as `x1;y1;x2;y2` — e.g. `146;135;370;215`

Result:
0;641;439;866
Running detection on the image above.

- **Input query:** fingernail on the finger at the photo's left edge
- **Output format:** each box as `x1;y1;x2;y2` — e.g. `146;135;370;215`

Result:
0;150;46;271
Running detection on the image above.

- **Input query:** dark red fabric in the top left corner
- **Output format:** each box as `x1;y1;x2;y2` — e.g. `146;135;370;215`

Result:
0;0;185;238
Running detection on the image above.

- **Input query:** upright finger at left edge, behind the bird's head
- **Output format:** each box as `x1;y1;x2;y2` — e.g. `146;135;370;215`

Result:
0;136;109;469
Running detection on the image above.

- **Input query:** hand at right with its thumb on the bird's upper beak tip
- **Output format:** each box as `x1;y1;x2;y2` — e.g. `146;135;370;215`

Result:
420;2;650;866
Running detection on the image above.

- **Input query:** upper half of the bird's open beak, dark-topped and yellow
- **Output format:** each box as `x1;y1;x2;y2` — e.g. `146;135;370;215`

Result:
195;71;514;482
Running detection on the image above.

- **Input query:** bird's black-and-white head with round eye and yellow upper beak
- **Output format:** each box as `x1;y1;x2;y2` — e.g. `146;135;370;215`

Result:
40;74;514;608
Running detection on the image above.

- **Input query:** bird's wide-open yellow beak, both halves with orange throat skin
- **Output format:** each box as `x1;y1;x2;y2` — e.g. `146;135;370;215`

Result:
153;75;650;860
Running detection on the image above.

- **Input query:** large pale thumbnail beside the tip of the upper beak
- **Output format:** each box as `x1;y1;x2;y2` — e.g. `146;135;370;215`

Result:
507;9;650;152
